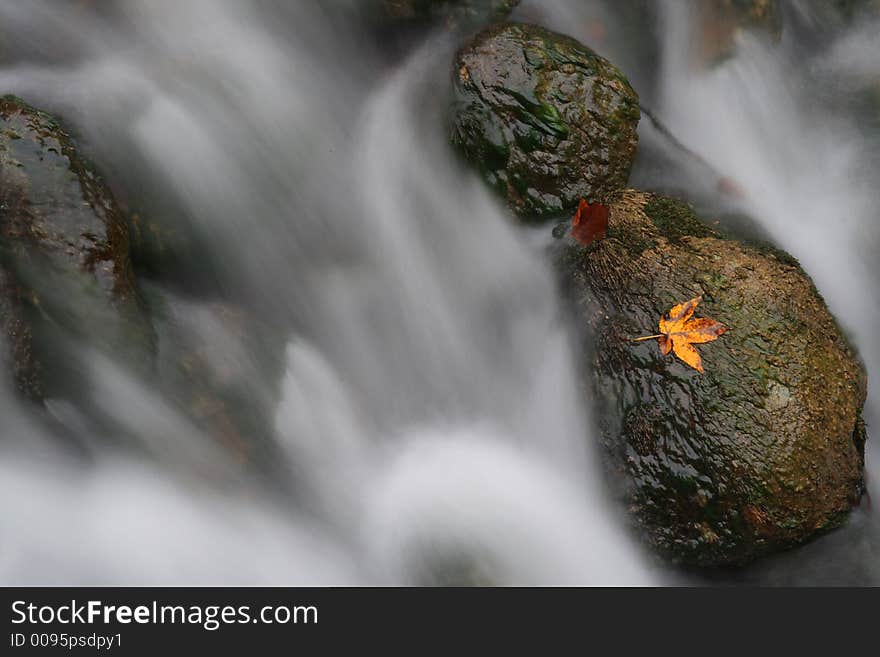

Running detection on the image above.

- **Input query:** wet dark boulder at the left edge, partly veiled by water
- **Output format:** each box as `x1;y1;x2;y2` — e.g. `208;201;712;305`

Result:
0;96;152;399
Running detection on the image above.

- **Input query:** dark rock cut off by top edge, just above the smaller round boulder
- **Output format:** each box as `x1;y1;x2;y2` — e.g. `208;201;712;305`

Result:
380;0;519;30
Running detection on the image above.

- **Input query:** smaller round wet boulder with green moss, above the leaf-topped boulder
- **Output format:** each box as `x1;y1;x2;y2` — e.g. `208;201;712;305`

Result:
451;23;639;219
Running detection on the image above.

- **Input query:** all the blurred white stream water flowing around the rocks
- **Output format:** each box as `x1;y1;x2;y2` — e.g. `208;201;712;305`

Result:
0;0;880;584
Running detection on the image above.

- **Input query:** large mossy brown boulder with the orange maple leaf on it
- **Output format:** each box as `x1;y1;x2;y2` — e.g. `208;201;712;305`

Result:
556;190;866;566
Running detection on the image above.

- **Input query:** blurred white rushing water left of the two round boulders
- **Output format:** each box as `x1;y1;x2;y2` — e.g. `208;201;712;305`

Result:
0;0;653;584
